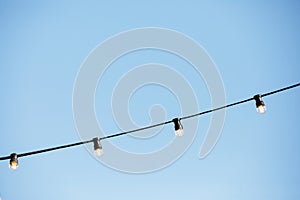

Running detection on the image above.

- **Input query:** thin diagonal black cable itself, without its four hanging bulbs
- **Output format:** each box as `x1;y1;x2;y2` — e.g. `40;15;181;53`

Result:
0;83;300;160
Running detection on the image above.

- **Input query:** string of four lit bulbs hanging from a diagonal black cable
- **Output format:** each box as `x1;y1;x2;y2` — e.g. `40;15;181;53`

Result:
0;83;300;170
